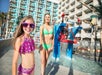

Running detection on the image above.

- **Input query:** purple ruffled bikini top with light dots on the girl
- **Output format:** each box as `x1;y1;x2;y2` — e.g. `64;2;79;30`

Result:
19;38;35;54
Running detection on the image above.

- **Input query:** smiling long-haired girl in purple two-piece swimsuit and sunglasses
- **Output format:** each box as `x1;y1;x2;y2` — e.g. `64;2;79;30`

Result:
12;16;35;75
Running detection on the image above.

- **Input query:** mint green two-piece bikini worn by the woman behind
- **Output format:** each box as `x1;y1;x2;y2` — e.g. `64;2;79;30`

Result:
42;28;53;50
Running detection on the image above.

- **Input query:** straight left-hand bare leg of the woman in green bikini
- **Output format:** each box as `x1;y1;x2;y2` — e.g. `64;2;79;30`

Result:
40;50;46;75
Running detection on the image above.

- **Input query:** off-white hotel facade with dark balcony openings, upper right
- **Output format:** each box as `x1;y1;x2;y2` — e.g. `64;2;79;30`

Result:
58;0;101;48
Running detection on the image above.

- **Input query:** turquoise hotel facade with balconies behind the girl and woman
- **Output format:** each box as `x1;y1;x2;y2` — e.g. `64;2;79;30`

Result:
8;0;58;37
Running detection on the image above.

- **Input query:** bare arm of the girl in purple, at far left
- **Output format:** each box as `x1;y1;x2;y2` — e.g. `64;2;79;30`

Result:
12;38;21;75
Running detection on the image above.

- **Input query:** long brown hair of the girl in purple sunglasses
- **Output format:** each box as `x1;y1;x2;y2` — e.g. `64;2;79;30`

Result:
13;15;34;47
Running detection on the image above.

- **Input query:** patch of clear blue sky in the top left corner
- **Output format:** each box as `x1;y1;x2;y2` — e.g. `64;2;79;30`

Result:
0;0;9;12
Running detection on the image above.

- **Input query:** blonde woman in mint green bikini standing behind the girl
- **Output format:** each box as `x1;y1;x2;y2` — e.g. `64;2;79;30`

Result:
40;14;54;75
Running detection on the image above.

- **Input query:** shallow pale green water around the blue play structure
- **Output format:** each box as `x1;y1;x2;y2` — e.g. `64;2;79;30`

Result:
49;50;102;75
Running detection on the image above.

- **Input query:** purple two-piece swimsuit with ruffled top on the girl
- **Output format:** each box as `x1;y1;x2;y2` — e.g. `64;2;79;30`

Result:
18;38;35;75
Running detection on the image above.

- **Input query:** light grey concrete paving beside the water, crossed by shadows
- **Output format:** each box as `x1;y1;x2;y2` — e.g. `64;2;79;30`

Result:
0;48;89;75
